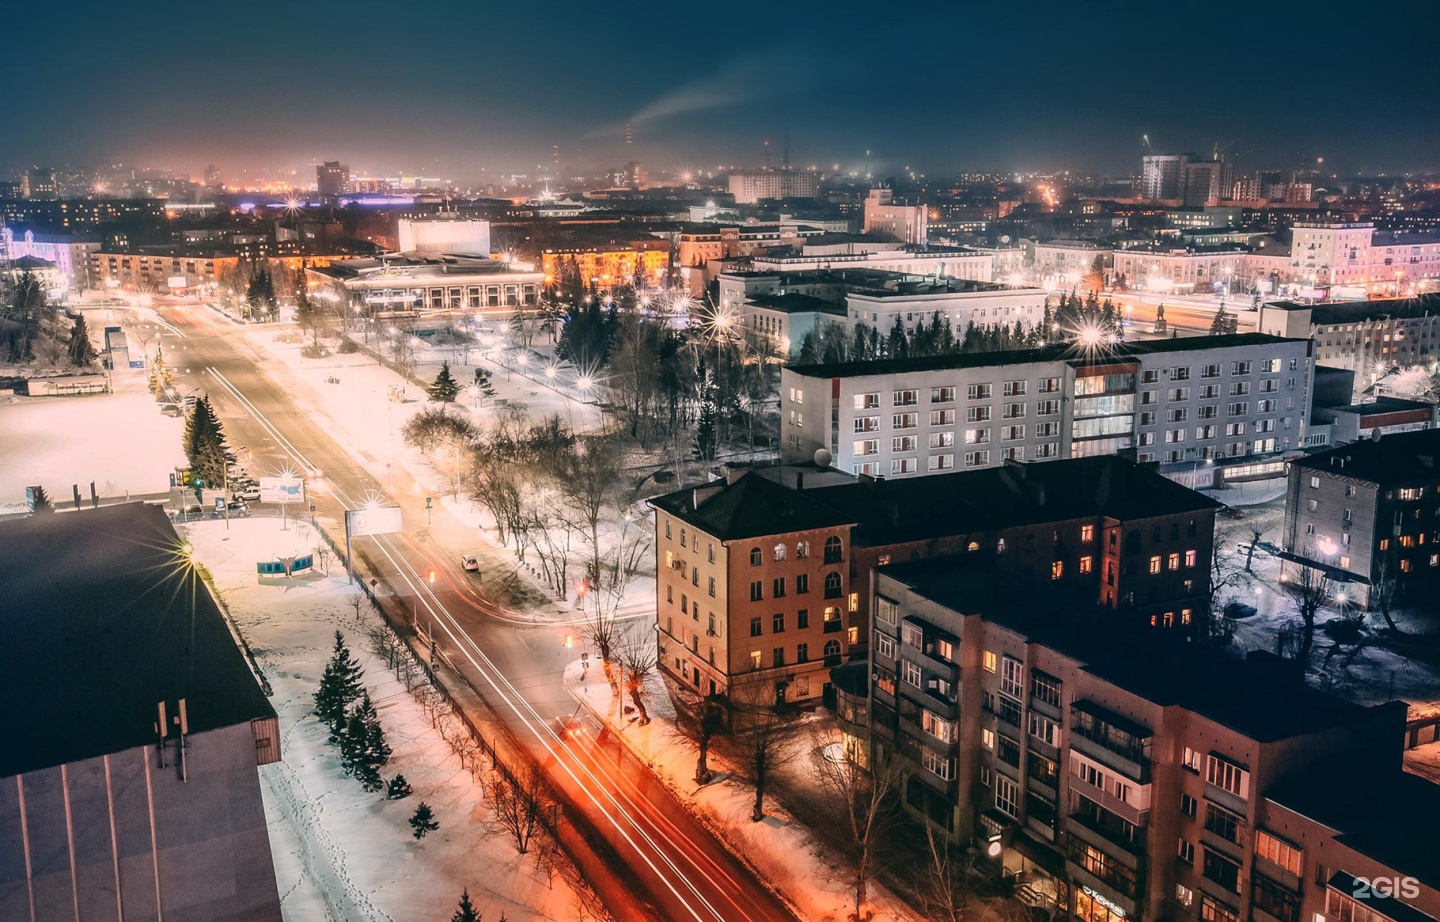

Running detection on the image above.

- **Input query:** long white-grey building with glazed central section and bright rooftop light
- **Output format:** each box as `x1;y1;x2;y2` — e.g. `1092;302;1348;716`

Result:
780;333;1312;485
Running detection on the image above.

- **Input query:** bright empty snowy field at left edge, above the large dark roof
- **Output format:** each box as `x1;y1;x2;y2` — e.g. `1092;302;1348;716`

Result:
0;370;184;514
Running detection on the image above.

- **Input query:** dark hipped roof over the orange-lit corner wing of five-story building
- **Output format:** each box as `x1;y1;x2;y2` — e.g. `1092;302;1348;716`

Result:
649;473;855;542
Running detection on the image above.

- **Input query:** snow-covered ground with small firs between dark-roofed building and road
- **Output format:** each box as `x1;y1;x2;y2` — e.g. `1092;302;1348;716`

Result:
189;519;580;922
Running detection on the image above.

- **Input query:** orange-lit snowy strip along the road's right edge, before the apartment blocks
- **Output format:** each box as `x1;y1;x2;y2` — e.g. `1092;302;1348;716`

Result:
564;663;920;922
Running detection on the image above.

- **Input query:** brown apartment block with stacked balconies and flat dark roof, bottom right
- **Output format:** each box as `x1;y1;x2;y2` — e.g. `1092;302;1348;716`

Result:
867;560;1410;922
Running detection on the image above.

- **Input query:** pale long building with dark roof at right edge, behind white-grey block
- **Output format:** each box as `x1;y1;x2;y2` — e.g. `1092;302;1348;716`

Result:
1256;294;1440;386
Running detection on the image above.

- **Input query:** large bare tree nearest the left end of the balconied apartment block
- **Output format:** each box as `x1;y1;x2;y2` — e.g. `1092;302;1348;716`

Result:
816;751;900;922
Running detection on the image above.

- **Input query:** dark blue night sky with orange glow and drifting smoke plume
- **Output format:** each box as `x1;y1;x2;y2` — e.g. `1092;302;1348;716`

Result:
11;0;1440;179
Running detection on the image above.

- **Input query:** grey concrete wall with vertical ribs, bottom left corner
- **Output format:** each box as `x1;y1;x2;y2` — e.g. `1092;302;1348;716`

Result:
0;723;281;922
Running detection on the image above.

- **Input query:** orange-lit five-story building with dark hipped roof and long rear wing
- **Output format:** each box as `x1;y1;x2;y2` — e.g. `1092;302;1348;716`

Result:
651;457;1218;700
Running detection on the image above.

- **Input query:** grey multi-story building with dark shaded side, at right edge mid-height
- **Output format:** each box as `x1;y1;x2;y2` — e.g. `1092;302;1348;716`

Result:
1280;429;1440;607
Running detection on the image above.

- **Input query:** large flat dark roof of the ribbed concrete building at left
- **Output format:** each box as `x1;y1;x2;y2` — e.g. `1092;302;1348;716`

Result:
0;503;275;778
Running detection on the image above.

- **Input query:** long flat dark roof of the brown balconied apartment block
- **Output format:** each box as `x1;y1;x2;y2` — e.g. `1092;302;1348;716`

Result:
877;555;1404;742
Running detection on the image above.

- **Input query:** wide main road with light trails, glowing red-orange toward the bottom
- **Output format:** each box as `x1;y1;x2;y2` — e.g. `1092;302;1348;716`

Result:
157;305;795;922
